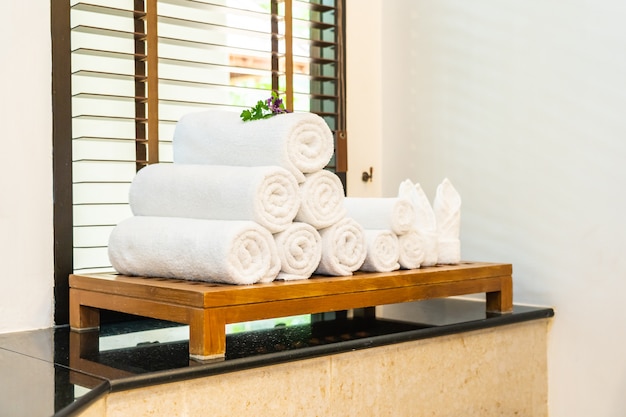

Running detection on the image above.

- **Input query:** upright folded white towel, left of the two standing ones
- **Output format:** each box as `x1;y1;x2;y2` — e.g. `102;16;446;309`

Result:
398;179;439;266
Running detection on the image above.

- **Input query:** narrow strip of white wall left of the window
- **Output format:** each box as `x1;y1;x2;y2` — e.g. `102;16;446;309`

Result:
0;0;54;333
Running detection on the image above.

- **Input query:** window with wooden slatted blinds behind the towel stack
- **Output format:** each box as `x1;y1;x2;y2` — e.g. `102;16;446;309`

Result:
51;0;347;321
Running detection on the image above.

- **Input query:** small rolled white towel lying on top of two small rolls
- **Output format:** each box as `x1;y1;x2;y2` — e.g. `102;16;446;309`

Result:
344;197;415;235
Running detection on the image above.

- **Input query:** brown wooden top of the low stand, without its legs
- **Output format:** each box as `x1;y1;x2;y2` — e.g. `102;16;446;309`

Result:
70;263;511;307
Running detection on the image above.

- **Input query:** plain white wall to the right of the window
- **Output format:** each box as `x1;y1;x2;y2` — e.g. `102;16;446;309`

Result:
356;0;626;417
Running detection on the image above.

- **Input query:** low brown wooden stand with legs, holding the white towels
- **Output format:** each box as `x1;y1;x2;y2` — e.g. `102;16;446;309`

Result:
70;262;513;360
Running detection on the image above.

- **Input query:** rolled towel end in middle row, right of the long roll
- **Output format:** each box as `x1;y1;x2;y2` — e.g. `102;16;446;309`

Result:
296;170;346;229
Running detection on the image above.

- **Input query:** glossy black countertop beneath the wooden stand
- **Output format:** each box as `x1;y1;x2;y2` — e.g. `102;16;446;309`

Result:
0;298;554;417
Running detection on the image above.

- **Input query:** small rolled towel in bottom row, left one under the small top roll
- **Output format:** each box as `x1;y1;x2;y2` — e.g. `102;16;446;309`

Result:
359;229;400;272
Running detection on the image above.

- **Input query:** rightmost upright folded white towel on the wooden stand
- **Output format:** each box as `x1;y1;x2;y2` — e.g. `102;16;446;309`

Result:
433;178;461;264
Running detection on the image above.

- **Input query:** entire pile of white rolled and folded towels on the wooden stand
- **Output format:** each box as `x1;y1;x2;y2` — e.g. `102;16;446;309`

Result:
109;106;448;284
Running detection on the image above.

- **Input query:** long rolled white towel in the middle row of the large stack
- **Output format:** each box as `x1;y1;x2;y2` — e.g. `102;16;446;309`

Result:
129;164;300;233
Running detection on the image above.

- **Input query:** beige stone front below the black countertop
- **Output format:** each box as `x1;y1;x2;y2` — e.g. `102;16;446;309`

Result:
77;319;549;417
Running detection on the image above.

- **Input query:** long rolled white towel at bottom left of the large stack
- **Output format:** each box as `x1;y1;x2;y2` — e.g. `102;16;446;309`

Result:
109;216;280;284
